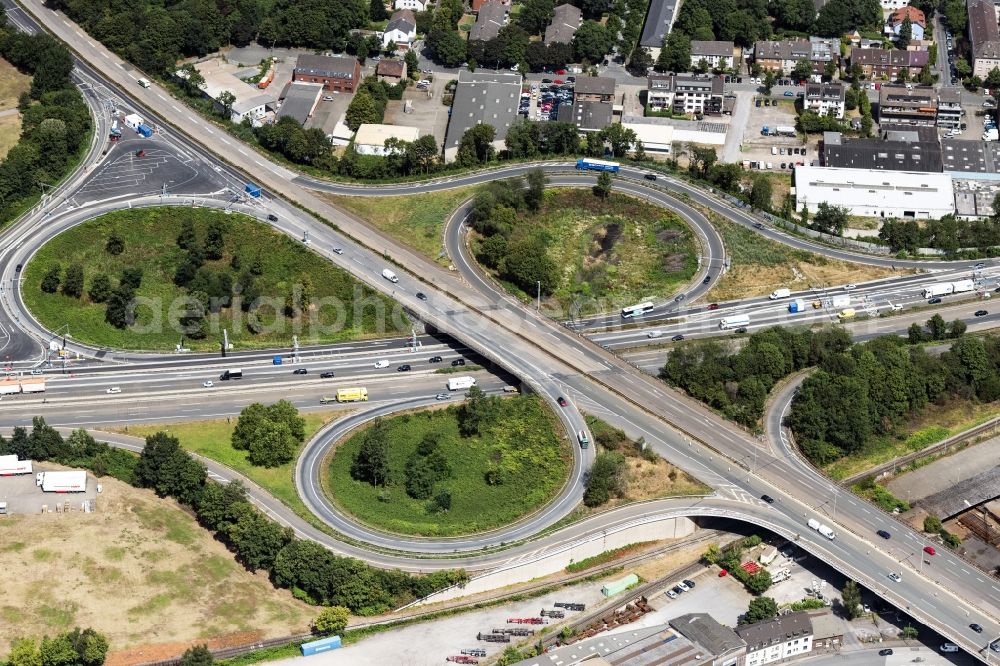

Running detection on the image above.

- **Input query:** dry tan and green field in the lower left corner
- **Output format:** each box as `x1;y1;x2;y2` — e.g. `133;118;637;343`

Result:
0;478;316;666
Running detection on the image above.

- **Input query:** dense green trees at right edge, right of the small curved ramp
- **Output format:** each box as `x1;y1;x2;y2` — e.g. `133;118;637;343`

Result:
787;334;1000;465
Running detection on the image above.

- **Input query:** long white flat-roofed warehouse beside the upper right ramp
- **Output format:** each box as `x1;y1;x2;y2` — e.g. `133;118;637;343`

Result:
795;165;955;219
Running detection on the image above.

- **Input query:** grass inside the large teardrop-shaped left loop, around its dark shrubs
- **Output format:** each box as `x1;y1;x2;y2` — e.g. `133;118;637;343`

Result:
23;207;408;351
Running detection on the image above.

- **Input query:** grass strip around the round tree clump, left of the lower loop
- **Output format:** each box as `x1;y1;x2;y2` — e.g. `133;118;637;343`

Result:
118;411;349;519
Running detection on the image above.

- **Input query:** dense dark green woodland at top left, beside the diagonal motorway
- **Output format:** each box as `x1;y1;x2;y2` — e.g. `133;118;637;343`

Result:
49;0;370;74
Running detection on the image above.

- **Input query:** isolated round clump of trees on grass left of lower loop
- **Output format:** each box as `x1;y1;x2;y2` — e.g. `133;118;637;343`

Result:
231;400;306;467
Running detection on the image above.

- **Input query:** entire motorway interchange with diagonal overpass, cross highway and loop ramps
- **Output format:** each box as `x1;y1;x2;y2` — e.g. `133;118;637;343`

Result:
0;1;1000;661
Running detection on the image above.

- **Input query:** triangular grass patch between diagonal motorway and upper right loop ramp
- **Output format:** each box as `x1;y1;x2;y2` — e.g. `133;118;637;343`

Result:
326;187;472;264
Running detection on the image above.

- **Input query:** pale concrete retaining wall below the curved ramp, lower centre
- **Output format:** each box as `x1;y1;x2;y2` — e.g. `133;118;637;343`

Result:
412;517;695;606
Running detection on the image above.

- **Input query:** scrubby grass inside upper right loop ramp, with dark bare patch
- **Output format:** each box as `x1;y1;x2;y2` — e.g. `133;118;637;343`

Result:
486;188;698;316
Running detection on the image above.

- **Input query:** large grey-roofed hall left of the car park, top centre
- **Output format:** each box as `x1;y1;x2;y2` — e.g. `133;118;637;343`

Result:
444;70;522;161
